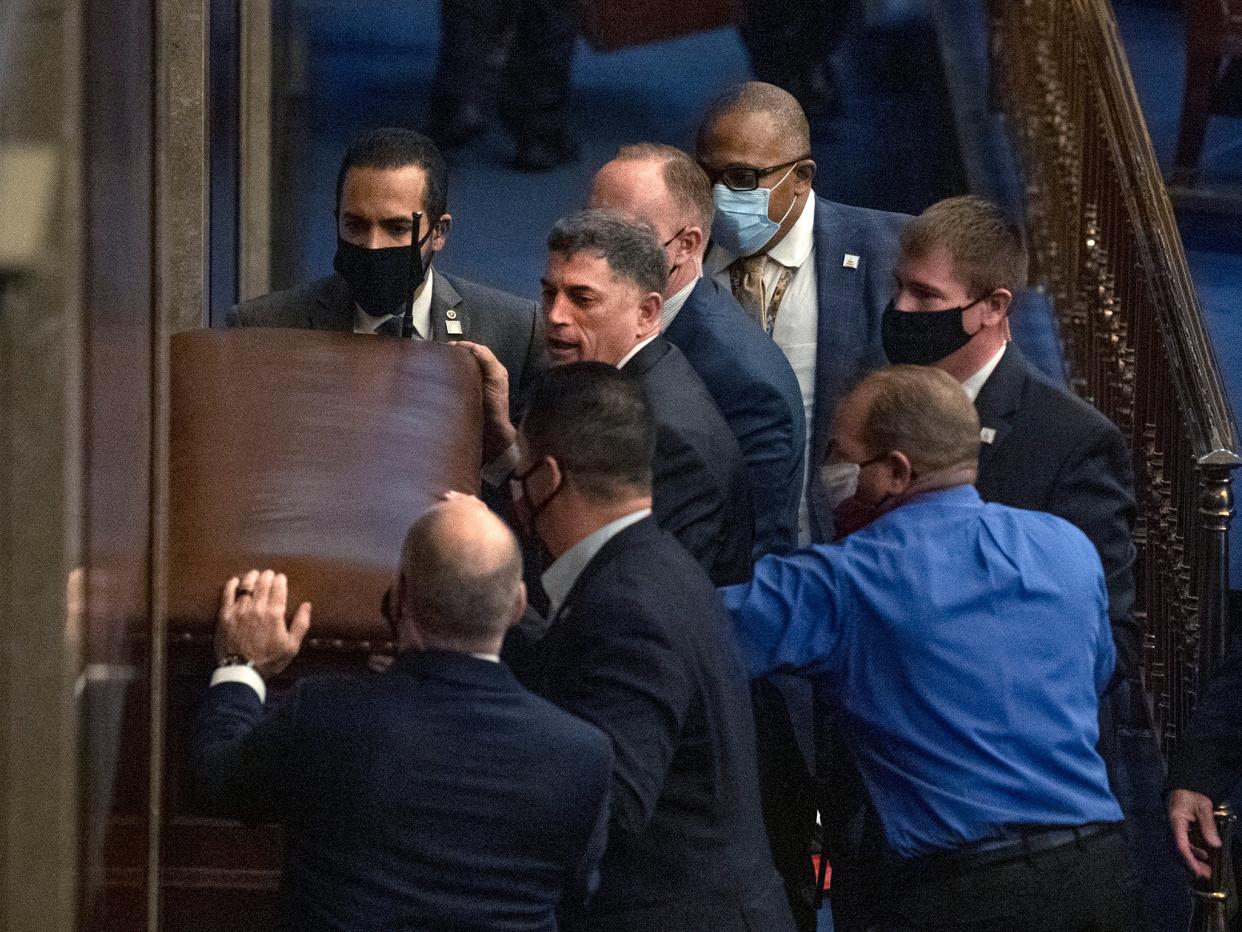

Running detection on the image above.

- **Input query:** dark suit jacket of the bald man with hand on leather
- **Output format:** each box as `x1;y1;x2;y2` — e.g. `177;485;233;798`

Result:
191;650;612;932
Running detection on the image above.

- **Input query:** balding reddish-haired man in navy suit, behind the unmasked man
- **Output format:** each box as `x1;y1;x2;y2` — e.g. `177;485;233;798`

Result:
590;143;806;559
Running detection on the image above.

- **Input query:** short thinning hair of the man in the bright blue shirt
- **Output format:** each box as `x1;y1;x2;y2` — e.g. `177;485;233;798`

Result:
850;365;979;472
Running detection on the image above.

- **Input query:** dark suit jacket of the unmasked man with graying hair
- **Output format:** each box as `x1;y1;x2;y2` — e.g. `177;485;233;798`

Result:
625;337;754;585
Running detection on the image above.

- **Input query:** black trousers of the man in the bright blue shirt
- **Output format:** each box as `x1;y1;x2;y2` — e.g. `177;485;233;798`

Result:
869;825;1146;932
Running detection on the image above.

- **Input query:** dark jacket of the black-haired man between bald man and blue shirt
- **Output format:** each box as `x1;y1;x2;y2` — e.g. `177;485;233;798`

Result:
524;518;792;932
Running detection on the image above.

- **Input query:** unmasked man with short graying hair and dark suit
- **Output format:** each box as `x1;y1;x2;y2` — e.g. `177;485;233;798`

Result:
467;210;754;585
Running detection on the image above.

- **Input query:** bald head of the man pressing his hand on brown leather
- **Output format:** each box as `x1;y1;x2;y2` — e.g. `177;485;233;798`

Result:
399;496;525;654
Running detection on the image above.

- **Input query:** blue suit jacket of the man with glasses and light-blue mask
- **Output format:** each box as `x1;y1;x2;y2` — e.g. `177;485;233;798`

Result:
806;196;910;542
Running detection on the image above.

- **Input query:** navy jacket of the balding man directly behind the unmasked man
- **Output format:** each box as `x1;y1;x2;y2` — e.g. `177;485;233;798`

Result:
664;276;806;559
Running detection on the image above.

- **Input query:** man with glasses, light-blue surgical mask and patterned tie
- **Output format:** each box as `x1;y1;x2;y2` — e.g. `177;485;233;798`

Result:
696;81;909;544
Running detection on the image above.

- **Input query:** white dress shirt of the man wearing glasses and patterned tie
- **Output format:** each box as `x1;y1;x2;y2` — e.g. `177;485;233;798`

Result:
707;195;820;547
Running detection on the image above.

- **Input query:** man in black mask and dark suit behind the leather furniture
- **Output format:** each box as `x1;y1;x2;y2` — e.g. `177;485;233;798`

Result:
226;128;546;407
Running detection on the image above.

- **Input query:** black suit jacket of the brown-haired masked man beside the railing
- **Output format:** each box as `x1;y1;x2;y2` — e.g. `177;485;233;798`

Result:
975;343;1143;677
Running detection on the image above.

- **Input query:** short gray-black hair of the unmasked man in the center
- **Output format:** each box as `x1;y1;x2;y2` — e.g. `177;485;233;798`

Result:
548;208;668;295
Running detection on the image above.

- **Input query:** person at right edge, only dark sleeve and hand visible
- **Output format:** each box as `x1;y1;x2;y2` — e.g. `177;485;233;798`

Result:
1165;642;1242;877
